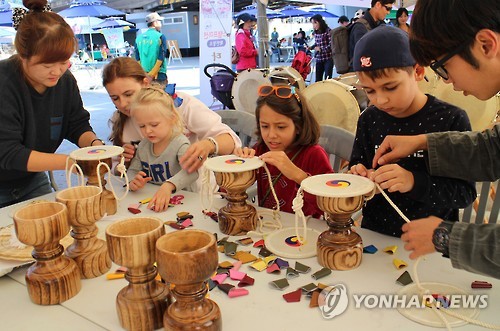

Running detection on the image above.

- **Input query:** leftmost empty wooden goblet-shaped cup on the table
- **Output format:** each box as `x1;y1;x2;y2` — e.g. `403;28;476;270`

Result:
14;202;81;305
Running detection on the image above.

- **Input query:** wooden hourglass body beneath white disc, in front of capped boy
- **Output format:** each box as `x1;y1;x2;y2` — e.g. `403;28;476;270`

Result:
316;195;366;270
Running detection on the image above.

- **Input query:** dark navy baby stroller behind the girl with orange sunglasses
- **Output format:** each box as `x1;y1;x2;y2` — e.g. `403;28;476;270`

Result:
203;63;237;109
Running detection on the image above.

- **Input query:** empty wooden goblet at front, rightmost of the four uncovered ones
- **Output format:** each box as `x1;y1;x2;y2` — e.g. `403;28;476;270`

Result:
156;230;222;331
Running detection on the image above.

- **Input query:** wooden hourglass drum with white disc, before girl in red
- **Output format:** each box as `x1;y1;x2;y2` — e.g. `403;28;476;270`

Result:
204;155;264;236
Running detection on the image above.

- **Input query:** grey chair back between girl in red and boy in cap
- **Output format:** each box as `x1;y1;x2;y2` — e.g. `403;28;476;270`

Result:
319;125;355;172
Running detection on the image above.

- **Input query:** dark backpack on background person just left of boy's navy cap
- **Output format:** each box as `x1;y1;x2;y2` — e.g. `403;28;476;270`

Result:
331;18;372;74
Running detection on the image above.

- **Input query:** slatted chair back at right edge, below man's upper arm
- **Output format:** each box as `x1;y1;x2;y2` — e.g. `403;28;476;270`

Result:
462;181;500;223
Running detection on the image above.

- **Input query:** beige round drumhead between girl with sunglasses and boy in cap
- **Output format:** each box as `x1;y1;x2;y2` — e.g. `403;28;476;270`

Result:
302;79;360;133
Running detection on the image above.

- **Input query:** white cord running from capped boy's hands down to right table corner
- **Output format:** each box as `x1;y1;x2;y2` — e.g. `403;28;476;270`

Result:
375;183;500;330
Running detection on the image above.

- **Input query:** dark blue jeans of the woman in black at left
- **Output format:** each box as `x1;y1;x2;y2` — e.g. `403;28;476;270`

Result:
0;172;52;208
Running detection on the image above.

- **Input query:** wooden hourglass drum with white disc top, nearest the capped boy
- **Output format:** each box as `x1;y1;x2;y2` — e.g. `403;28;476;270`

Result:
301;174;375;270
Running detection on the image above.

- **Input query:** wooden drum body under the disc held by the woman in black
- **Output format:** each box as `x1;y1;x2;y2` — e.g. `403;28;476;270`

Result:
76;157;118;215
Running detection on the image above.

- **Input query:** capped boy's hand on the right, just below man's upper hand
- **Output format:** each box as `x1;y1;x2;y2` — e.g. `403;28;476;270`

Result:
370;164;415;193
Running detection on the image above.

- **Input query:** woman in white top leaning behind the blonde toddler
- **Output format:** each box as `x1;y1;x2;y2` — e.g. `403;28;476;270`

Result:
102;57;241;187
